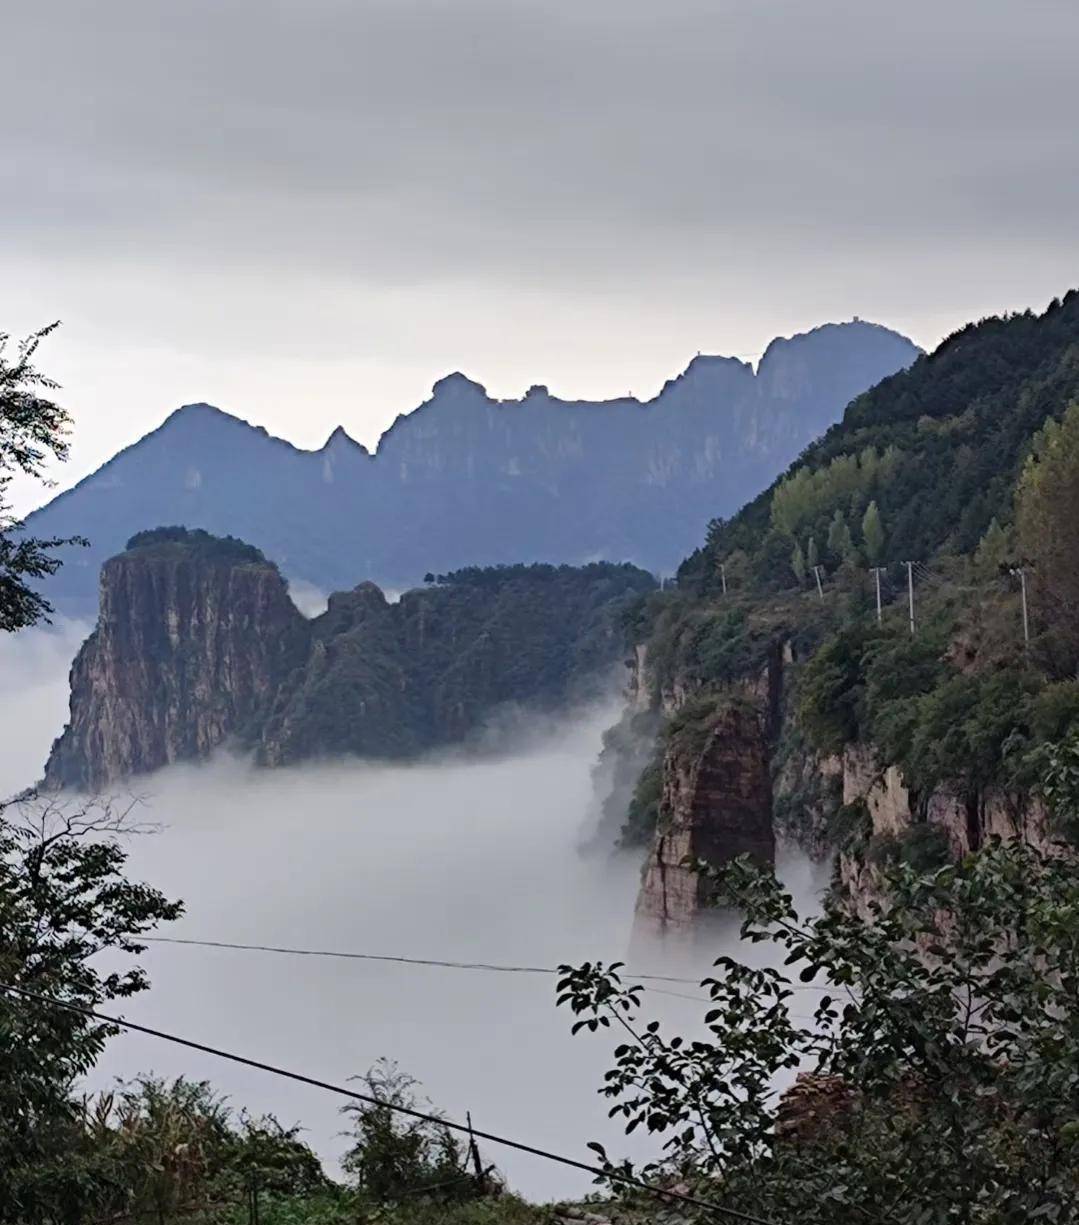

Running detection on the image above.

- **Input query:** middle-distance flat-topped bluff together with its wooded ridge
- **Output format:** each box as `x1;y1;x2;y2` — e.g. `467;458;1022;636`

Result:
45;528;655;789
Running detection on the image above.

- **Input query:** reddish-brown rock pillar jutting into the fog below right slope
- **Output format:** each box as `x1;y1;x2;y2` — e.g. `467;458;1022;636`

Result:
637;704;775;932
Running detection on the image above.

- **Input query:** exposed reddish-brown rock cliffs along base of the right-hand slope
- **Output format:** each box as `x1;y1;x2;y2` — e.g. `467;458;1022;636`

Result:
614;592;1051;931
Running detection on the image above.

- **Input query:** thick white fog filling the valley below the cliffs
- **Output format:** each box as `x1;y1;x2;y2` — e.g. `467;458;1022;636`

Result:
0;626;823;1198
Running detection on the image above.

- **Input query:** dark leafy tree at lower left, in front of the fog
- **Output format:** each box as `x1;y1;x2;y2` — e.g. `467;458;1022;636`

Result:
0;797;182;1223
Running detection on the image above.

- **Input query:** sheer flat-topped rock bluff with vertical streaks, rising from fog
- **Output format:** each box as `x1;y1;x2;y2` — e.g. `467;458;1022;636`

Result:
45;546;306;790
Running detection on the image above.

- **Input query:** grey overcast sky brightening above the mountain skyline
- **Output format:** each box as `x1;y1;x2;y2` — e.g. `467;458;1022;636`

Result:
0;0;1079;506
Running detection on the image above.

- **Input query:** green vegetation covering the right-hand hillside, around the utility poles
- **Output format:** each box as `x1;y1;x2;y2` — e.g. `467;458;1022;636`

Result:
625;292;1079;854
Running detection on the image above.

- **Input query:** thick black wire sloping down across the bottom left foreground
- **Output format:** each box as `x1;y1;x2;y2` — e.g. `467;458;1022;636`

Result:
0;984;772;1225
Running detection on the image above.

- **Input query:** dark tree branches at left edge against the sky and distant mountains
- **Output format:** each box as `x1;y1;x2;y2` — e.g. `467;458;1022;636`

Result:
0;323;86;631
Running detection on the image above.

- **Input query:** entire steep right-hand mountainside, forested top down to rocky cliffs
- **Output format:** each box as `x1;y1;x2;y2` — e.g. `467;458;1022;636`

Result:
607;292;1079;926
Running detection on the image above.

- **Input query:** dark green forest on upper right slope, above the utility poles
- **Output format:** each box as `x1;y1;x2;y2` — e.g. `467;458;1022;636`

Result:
679;290;1079;588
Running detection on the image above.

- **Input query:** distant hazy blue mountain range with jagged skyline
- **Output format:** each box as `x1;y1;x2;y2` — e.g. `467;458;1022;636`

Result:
27;321;920;617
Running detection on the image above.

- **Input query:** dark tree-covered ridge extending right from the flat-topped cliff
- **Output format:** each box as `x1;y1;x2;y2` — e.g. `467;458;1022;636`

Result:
263;565;655;762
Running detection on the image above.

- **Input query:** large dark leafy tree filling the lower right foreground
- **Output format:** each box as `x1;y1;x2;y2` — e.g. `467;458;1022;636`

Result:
558;842;1079;1225
